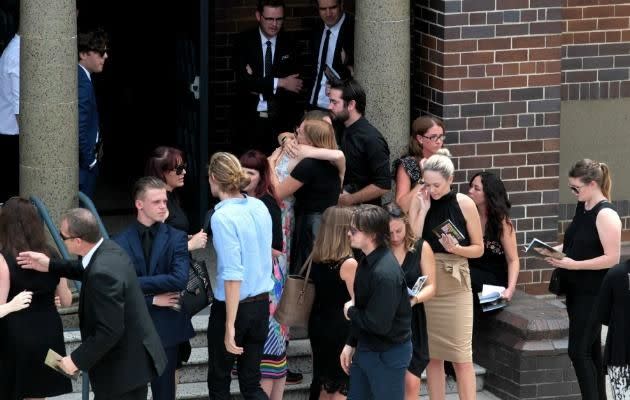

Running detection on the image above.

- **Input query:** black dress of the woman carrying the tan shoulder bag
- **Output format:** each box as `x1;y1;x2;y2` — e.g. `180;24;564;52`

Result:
308;258;350;399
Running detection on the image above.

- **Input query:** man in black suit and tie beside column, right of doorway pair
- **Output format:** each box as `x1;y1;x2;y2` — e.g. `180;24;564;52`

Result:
308;0;354;110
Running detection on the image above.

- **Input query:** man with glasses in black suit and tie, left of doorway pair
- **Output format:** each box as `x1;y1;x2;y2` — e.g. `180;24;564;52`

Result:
234;0;302;154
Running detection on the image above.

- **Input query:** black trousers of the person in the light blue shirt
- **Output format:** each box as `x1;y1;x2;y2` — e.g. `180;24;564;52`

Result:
208;300;269;400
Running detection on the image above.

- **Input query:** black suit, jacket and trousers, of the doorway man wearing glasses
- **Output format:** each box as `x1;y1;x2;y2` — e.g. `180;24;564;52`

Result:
233;27;301;154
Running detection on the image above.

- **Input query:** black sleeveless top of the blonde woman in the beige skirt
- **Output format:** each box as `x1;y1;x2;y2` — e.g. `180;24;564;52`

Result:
422;190;470;253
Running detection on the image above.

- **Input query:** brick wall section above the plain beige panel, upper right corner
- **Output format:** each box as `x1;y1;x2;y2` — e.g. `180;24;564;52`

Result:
562;0;630;100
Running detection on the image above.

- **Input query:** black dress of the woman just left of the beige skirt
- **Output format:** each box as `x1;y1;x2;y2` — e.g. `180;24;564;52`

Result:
401;239;429;378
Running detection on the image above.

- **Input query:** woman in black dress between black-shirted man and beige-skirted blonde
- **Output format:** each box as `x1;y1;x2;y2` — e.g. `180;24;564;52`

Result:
386;203;435;400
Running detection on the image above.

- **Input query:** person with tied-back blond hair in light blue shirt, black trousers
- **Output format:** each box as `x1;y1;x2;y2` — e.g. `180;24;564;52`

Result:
207;152;273;399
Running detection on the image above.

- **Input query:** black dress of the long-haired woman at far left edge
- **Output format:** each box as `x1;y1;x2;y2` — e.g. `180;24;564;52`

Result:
0;253;72;400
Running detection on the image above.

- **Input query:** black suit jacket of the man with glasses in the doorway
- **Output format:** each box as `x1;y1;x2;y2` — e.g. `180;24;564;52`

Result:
234;27;301;128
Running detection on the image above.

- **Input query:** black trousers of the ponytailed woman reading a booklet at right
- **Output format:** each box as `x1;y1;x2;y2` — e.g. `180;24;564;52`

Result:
567;293;606;400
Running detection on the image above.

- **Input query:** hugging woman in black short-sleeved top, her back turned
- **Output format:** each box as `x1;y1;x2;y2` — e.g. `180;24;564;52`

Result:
269;120;345;271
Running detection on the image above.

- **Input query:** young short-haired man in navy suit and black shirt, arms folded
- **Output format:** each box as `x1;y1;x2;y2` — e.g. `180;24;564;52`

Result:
114;176;195;400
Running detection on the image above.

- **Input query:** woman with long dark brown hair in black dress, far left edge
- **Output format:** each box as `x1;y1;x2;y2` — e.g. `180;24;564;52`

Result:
0;197;72;400
